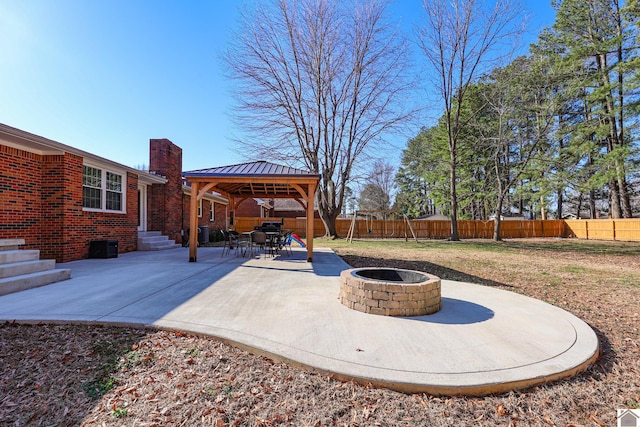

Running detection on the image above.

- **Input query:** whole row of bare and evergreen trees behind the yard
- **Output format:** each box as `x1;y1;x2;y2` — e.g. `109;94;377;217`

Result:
225;0;640;240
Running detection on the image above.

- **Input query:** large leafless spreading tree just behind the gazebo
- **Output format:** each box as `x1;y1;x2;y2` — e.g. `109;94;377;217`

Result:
226;0;412;237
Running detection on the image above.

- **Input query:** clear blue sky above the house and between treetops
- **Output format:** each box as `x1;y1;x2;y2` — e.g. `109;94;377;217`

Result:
0;0;553;170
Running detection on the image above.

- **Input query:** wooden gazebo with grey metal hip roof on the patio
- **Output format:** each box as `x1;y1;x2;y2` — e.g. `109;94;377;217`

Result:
182;161;320;262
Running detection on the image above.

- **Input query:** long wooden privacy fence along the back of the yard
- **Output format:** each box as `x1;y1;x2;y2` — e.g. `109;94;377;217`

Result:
236;218;640;241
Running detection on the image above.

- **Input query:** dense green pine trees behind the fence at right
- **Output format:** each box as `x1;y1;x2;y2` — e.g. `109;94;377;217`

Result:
396;0;640;238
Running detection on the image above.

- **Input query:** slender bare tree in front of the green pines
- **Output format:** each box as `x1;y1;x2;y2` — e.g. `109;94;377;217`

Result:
418;0;522;240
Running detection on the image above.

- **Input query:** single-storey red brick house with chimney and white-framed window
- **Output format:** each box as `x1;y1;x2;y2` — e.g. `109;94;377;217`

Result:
0;124;226;262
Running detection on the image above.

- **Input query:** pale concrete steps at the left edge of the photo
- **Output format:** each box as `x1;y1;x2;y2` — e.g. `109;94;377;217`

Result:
0;239;71;295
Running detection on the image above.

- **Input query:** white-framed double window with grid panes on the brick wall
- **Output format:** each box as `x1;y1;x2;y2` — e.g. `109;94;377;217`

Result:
82;165;125;212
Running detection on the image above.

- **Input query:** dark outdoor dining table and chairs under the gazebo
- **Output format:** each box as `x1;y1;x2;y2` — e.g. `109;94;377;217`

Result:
222;222;292;257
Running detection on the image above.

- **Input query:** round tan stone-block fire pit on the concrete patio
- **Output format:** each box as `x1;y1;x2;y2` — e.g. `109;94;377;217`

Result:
340;268;441;316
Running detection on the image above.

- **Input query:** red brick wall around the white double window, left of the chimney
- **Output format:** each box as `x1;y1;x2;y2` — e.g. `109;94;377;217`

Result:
0;145;138;262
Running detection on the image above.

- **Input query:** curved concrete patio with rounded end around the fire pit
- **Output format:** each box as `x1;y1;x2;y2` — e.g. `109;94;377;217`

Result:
0;248;598;395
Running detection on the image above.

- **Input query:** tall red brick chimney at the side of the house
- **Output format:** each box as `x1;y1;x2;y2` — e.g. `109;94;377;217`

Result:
147;138;183;242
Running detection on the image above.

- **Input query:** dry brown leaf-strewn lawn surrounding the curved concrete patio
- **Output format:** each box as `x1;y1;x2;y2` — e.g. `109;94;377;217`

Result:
0;239;640;426
